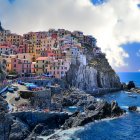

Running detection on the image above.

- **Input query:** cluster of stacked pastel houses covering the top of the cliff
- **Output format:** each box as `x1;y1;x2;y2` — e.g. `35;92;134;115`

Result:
0;24;101;78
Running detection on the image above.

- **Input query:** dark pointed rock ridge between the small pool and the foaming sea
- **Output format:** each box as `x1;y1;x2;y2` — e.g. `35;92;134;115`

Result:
63;101;125;129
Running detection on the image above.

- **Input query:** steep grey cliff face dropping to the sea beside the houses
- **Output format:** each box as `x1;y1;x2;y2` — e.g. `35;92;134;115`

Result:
66;49;121;92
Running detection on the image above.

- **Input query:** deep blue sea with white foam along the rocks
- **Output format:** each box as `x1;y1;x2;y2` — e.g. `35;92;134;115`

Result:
42;72;140;140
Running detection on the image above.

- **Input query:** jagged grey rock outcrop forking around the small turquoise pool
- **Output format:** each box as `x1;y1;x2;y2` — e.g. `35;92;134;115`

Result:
62;89;125;129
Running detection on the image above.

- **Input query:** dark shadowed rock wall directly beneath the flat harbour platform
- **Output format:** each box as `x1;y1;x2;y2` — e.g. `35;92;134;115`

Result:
12;111;69;129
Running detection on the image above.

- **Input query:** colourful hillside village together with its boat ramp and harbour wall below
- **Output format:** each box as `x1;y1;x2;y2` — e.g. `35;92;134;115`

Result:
0;22;102;112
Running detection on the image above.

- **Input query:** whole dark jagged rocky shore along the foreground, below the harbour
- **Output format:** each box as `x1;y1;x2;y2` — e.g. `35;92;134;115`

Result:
0;89;125;140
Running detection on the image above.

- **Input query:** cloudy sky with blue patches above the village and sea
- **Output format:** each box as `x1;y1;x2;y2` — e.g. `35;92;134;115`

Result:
0;0;140;72
